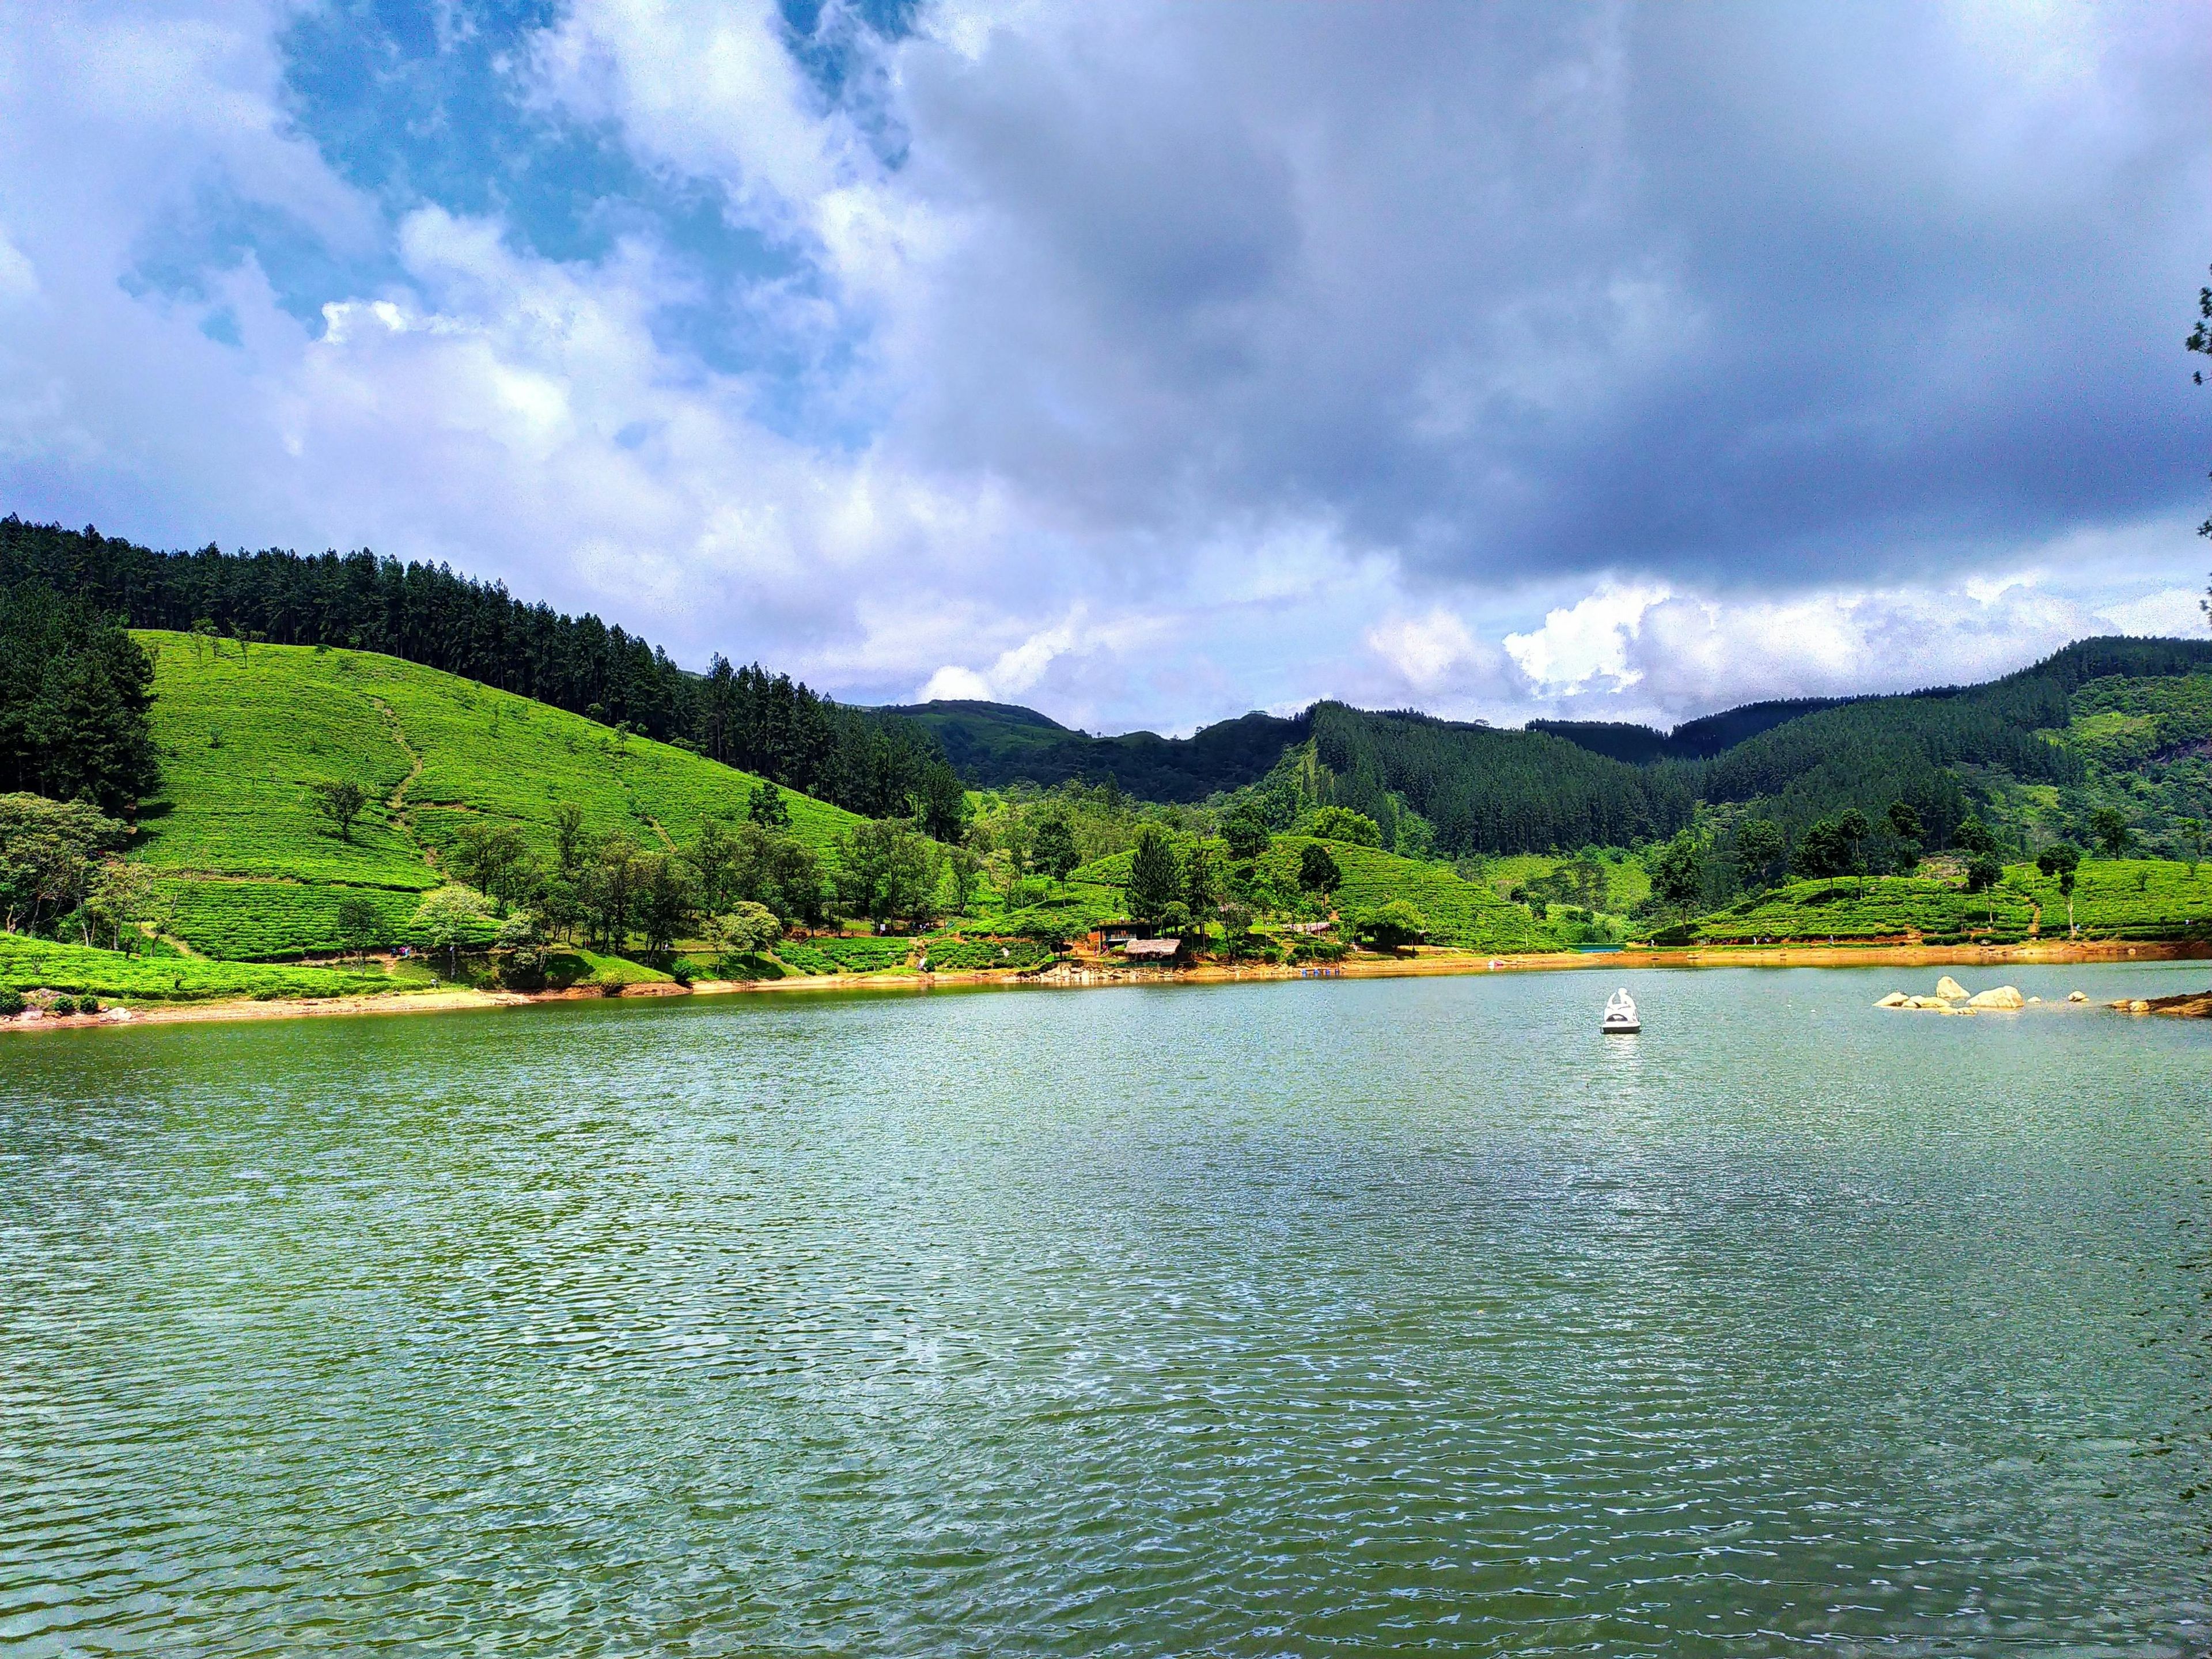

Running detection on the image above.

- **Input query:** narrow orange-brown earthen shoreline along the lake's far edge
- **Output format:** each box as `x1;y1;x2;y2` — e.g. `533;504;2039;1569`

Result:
0;940;2212;1031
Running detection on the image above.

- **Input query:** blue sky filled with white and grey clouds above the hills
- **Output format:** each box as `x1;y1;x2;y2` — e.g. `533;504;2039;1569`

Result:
0;0;2212;732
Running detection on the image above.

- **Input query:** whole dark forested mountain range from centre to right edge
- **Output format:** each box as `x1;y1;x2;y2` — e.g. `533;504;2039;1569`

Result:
892;639;2212;854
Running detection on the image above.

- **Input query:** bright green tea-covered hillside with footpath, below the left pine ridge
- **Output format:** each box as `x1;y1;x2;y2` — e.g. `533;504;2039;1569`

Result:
131;630;858;958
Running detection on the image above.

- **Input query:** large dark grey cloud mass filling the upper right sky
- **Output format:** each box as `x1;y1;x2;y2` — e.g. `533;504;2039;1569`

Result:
876;5;2212;586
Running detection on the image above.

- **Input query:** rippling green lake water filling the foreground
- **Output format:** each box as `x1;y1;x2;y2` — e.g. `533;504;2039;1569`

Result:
0;964;2212;1654
